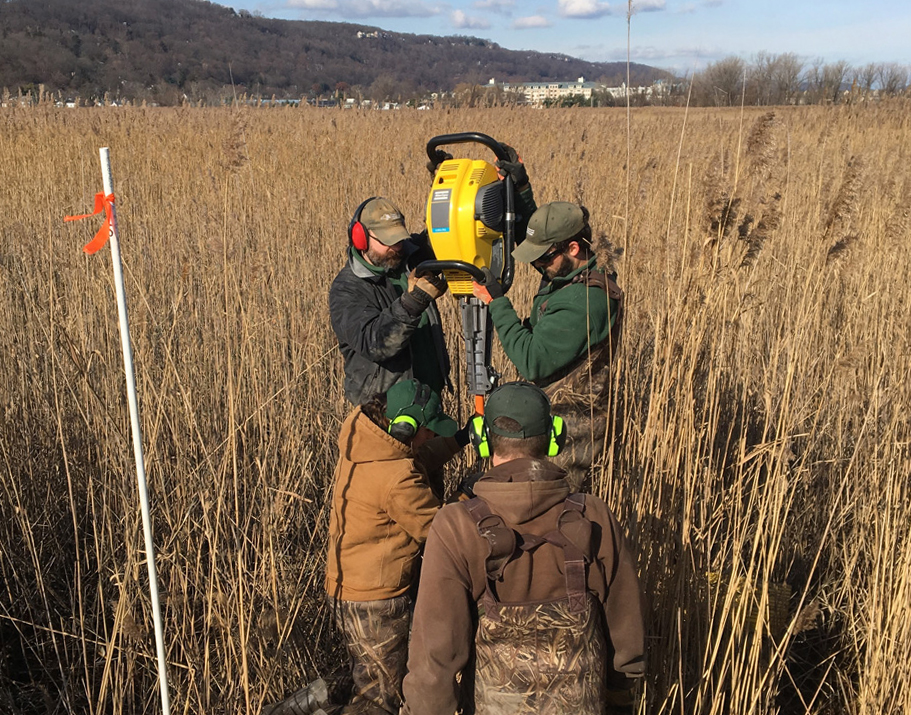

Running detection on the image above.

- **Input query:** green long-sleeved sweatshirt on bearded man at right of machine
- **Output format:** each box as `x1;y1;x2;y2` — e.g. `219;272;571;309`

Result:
489;257;619;387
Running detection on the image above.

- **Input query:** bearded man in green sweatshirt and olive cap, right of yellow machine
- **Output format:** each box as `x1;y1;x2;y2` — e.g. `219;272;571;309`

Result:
474;201;623;489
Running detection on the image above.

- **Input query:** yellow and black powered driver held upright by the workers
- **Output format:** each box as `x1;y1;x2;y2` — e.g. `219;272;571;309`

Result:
415;132;516;414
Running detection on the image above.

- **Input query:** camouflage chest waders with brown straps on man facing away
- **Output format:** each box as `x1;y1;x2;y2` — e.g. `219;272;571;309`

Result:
465;494;607;715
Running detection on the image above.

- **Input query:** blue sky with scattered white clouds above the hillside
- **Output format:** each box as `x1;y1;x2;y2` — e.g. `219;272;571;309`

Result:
219;0;911;74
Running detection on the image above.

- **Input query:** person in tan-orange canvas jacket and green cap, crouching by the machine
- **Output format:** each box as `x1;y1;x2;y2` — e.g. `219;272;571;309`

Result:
326;380;468;715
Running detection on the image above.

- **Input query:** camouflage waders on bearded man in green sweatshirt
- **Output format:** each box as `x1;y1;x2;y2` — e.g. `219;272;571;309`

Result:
540;271;623;492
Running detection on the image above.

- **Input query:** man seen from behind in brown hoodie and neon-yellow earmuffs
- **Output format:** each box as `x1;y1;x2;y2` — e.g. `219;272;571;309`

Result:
402;382;644;715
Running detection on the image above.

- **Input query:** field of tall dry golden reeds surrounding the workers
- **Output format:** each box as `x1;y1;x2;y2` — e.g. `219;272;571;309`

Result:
0;102;911;715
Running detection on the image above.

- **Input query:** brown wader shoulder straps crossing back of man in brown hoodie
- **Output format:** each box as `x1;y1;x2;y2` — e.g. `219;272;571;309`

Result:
463;494;591;620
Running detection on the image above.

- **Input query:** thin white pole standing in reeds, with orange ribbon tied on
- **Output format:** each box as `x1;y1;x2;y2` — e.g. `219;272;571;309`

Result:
99;147;171;715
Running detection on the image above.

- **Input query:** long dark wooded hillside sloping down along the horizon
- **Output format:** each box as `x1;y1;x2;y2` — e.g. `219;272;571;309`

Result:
0;0;669;103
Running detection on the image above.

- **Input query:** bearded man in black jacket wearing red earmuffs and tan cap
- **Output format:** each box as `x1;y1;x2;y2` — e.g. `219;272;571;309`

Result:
329;144;535;405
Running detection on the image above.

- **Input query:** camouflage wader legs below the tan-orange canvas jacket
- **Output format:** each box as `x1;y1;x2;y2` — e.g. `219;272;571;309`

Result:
327;594;412;715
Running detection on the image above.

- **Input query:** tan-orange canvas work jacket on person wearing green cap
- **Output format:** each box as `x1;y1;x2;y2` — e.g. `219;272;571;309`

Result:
326;407;459;601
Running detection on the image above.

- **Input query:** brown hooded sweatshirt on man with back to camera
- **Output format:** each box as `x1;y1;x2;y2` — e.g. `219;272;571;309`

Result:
402;459;644;715
